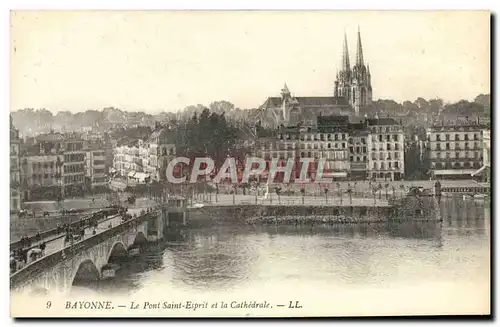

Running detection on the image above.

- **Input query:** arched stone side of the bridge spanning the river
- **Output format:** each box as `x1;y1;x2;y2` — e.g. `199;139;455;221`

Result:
10;207;186;294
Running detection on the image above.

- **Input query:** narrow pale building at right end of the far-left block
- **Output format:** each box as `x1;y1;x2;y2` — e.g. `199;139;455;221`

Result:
84;141;108;192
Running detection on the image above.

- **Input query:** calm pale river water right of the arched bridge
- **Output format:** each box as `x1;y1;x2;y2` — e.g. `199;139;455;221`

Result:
72;199;490;315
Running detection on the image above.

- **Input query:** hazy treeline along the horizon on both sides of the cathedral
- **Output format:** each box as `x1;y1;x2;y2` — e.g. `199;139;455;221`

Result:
11;94;491;135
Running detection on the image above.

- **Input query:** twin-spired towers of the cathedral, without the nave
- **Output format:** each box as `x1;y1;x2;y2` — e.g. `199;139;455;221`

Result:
334;27;372;116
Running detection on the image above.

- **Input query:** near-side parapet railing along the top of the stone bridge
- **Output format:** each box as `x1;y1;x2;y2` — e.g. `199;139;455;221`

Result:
10;212;158;289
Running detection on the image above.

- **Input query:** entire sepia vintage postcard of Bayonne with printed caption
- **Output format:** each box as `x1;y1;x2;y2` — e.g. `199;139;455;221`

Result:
10;10;491;317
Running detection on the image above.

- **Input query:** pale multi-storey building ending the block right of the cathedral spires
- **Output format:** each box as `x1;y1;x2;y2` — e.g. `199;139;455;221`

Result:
366;118;405;181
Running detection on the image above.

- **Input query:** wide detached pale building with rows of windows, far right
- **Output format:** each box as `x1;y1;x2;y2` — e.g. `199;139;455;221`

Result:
427;120;486;179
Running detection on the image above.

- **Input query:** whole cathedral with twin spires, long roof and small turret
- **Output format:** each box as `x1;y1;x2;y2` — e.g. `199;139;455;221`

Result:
261;29;372;127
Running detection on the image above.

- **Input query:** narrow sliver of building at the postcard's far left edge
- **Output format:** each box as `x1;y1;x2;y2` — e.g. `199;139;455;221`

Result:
10;116;21;211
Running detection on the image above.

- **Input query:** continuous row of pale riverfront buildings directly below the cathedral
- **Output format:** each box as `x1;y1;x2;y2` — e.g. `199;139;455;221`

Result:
254;116;404;181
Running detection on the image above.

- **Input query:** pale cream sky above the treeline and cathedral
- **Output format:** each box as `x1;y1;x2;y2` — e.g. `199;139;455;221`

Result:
10;11;490;113
